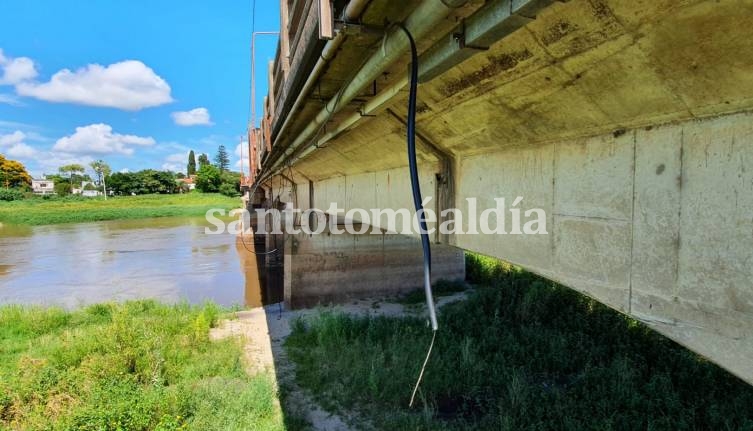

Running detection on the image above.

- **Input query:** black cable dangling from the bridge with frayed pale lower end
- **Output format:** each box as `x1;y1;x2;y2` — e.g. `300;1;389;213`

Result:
399;24;439;407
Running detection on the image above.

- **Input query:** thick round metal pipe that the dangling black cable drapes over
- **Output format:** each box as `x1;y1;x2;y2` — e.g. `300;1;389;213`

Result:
264;0;467;179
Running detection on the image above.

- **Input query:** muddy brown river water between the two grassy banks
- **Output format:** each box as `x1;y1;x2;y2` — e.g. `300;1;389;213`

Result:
0;218;279;308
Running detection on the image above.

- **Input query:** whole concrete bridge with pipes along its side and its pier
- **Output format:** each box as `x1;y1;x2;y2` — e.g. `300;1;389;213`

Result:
249;0;753;383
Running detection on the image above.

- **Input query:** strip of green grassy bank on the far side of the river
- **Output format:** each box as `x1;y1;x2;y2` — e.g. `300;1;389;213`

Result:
0;193;240;225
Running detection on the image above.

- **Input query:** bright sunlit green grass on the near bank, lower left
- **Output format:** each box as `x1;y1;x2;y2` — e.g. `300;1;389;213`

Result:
0;301;284;431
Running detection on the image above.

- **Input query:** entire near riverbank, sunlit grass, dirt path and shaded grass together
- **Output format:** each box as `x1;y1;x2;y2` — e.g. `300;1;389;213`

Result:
5;255;753;431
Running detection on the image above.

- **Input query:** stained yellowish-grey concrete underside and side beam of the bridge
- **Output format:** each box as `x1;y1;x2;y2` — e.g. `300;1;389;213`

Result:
262;0;753;383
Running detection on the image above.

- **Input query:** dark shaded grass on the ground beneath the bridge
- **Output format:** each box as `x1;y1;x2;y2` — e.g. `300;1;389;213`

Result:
286;256;753;430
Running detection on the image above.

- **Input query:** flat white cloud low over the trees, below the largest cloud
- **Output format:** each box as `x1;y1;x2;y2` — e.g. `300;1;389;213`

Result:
52;124;155;156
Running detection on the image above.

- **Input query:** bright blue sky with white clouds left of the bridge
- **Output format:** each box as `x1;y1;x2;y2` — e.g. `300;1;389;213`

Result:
0;0;280;176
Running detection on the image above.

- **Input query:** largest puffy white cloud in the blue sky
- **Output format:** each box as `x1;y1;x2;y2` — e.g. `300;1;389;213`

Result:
16;60;173;111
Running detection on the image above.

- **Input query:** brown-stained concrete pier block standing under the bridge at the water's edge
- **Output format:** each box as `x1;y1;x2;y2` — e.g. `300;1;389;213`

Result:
284;228;465;308
